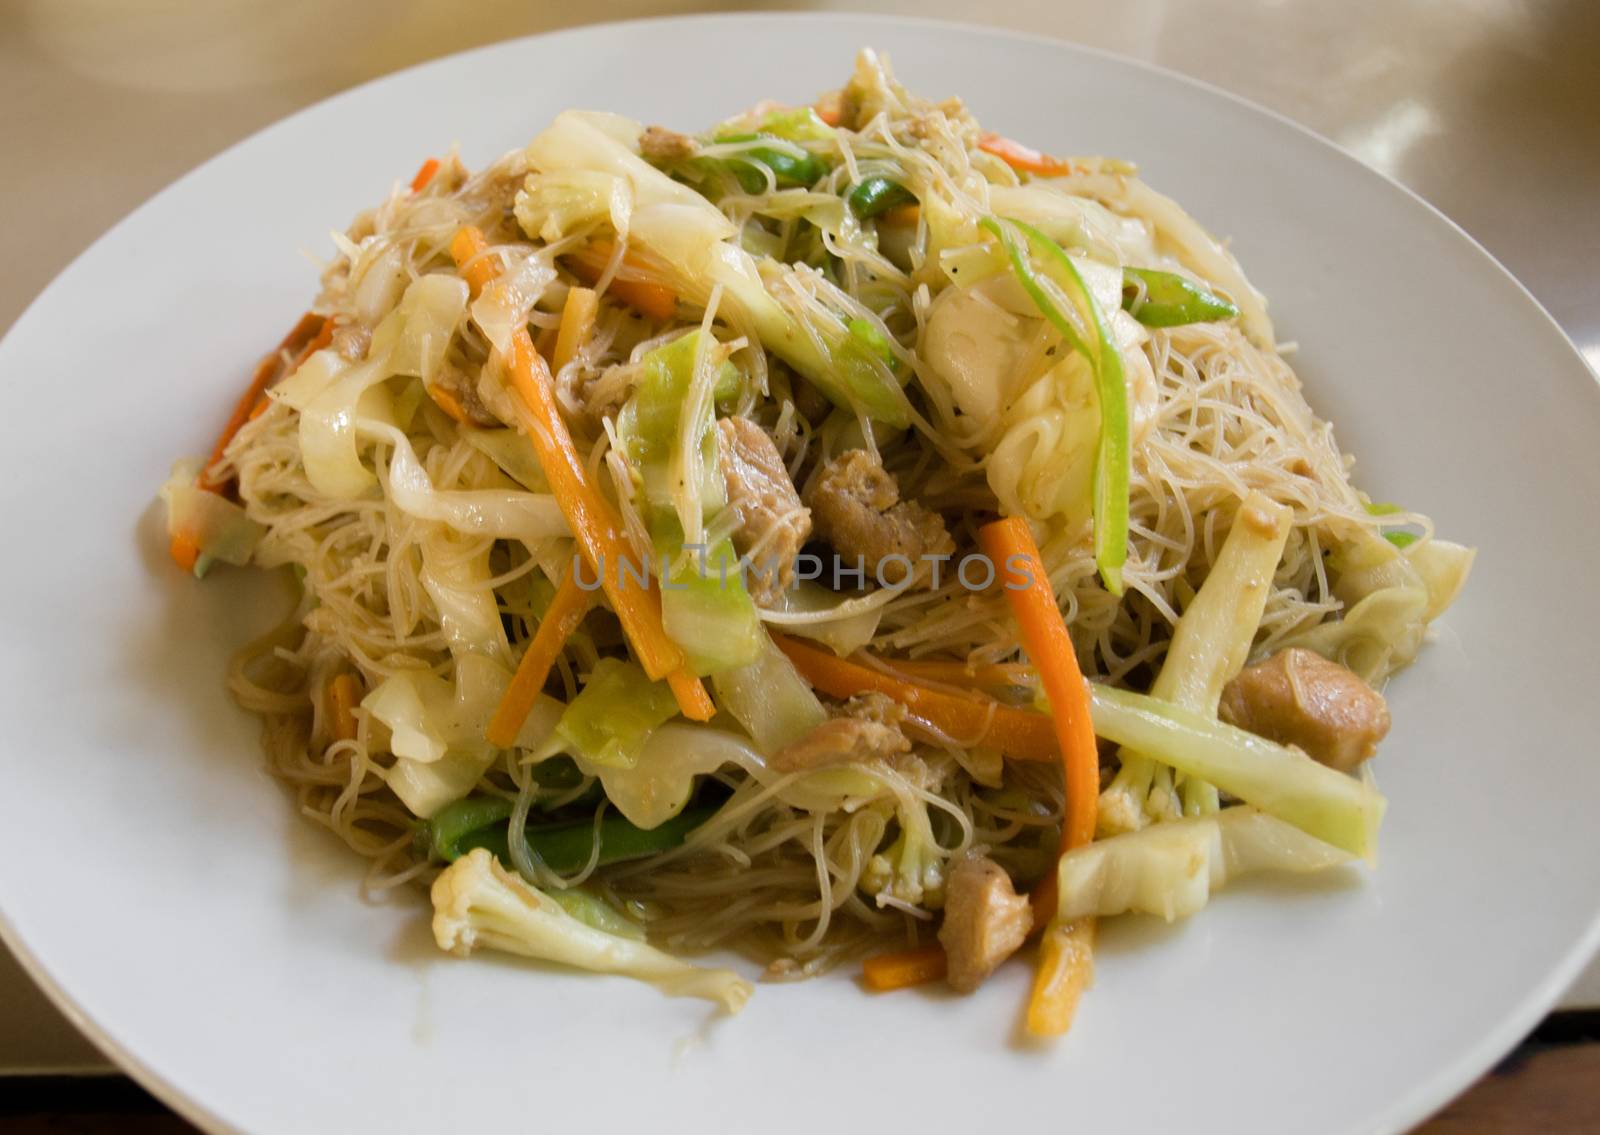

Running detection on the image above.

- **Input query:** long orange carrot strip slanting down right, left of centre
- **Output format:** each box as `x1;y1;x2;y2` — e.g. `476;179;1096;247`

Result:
450;226;706;717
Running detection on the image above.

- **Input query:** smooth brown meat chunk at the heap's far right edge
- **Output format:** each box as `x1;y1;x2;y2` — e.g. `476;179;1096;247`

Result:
1218;647;1389;772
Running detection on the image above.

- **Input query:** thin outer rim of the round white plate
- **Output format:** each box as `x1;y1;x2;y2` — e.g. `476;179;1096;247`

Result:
0;11;1600;1133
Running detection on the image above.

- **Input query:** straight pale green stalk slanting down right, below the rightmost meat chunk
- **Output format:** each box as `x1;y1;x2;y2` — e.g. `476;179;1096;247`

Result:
1090;682;1387;861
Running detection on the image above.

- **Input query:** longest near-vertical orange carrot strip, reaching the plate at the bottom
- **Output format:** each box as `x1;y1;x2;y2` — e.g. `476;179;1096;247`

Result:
978;517;1099;1036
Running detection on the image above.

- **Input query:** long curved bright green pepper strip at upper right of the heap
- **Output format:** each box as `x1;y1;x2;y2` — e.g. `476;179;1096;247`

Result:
981;216;1133;596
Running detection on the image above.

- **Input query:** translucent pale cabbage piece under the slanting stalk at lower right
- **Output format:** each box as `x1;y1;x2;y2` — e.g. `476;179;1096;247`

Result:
1056;807;1352;924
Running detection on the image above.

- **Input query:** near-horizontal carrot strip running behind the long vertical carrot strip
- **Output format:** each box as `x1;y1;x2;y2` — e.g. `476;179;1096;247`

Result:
773;634;1059;760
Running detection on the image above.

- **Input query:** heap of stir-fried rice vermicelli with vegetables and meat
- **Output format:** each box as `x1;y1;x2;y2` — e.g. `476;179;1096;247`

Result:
168;51;1470;1026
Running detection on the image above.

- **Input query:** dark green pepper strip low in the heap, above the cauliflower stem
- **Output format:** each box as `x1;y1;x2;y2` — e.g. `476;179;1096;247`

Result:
419;796;717;874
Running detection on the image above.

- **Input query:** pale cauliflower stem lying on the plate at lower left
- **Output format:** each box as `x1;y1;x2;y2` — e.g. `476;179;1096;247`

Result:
432;847;752;1013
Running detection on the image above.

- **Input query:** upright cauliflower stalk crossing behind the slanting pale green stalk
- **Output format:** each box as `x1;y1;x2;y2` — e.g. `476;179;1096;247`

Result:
1099;493;1291;832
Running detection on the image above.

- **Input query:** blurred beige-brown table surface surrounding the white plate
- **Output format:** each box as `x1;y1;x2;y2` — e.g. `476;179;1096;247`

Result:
0;0;1600;1132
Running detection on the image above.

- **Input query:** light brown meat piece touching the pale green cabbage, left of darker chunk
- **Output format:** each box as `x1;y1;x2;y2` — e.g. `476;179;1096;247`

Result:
717;418;811;604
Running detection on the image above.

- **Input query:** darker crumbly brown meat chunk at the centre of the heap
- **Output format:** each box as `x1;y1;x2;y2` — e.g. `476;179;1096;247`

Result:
806;450;955;586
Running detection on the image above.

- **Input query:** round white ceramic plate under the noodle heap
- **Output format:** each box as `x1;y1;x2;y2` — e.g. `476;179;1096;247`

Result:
0;16;1600;1133
